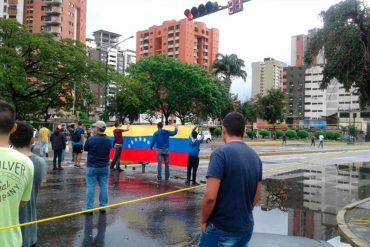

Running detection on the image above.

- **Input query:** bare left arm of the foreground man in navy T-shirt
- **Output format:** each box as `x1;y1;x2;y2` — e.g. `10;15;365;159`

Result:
200;177;221;232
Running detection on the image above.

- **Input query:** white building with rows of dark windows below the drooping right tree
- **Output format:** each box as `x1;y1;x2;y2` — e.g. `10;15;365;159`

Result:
304;65;360;119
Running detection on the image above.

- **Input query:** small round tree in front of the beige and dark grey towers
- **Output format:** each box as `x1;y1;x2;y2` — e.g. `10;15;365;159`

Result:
258;88;284;129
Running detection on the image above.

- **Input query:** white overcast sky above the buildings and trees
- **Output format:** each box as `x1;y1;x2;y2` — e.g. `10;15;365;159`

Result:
87;0;350;100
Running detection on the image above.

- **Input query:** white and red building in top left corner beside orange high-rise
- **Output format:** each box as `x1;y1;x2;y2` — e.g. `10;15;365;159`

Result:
0;0;25;23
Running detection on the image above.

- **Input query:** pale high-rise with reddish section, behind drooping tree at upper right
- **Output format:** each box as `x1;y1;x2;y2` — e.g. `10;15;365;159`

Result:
290;28;324;66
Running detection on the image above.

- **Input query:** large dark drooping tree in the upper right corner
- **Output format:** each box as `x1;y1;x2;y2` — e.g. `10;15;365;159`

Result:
305;0;370;106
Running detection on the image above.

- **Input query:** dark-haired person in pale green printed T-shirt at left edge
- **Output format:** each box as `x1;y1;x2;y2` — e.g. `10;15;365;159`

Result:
0;101;34;247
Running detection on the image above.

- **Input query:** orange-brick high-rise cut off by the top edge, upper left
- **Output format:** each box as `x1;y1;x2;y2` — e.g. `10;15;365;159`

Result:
20;0;86;43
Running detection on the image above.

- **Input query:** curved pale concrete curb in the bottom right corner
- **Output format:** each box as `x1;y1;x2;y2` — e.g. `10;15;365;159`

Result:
337;197;370;247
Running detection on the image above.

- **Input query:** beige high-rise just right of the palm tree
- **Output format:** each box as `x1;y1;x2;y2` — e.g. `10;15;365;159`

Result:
252;58;286;97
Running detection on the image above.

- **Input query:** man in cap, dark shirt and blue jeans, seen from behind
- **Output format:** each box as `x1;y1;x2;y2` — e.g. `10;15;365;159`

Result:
84;121;112;214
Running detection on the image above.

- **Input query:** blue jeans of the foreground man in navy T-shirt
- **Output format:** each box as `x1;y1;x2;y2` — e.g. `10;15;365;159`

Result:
199;224;253;247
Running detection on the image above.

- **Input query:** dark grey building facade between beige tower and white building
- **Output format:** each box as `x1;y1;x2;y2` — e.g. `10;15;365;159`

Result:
283;66;305;124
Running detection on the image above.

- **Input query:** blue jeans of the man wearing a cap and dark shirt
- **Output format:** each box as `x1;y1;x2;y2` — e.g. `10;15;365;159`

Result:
86;166;109;209
